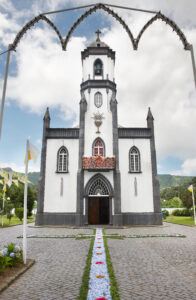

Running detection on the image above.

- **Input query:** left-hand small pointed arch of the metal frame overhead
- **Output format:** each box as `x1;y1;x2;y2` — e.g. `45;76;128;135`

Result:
11;15;64;50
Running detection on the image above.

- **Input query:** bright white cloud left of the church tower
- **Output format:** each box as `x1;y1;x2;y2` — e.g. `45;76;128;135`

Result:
7;28;85;119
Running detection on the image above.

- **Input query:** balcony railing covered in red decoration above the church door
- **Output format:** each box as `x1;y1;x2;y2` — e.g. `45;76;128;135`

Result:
82;156;115;170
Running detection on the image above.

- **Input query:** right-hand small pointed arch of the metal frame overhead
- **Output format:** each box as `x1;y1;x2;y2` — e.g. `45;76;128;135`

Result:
134;12;190;50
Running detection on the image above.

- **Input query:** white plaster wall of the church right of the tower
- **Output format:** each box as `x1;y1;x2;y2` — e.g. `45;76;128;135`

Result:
119;139;154;213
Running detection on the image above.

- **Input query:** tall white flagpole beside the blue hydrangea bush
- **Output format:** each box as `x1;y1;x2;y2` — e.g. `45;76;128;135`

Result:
23;140;29;264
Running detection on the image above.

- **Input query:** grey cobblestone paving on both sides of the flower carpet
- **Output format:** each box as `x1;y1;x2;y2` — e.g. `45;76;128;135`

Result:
0;224;196;300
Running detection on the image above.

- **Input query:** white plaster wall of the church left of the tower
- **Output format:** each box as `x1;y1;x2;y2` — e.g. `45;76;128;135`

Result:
44;139;79;212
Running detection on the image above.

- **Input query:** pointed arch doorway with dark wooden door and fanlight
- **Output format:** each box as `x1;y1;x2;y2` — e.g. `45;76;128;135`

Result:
85;174;113;225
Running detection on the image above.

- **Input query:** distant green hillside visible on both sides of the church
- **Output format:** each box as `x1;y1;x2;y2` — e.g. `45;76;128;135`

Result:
3;168;193;189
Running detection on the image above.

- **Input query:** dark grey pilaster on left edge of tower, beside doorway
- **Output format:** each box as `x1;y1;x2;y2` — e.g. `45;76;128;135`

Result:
76;95;87;226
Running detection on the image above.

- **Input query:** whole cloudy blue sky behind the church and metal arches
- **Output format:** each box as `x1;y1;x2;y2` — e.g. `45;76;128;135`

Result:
0;0;196;176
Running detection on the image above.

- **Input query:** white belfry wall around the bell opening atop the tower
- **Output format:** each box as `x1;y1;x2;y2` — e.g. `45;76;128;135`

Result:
82;55;114;81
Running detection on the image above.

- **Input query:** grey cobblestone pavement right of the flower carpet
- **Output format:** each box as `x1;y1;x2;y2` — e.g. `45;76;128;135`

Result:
106;223;196;300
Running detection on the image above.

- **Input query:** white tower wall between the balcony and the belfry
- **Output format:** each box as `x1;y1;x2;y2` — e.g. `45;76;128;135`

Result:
84;89;113;157
